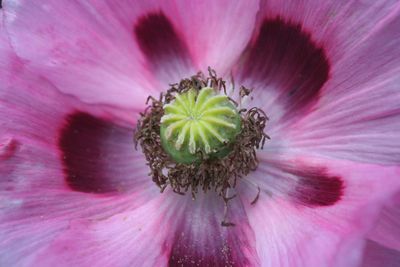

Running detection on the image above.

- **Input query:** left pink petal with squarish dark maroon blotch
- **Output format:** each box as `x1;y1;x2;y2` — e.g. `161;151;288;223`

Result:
0;66;159;266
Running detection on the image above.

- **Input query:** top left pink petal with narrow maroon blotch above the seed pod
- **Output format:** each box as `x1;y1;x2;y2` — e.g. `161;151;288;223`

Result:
4;0;258;105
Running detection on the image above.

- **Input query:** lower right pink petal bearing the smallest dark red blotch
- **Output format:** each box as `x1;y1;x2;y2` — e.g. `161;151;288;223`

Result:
239;156;400;266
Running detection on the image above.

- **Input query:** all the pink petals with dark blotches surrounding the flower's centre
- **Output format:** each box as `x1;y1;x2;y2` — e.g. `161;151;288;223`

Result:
0;0;400;267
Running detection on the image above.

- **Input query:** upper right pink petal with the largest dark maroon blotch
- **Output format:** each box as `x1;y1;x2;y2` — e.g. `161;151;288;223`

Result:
236;1;400;164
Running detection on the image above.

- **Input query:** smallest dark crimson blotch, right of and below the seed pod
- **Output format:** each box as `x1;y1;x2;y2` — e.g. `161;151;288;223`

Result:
290;167;344;207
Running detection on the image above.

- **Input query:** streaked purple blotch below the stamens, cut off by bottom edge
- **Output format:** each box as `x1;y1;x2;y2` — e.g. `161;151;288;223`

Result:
169;192;260;266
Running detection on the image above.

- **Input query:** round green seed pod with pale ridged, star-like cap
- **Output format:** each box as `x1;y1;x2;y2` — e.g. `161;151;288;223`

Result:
160;87;241;164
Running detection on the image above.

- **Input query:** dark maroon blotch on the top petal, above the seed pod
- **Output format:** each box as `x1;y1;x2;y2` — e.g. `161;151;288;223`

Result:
134;12;189;71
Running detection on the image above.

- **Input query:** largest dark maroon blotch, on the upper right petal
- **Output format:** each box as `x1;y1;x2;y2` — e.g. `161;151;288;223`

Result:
242;17;330;117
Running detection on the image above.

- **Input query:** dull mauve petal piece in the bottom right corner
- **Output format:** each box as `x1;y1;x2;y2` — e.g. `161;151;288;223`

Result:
361;241;400;267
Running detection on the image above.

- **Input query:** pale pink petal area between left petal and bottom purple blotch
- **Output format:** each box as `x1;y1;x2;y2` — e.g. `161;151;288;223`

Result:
22;197;174;267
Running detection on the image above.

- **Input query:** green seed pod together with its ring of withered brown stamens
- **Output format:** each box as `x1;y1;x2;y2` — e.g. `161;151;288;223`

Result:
134;69;268;201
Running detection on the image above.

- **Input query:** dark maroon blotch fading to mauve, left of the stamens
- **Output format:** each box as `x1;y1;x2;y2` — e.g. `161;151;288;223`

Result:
59;112;135;193
